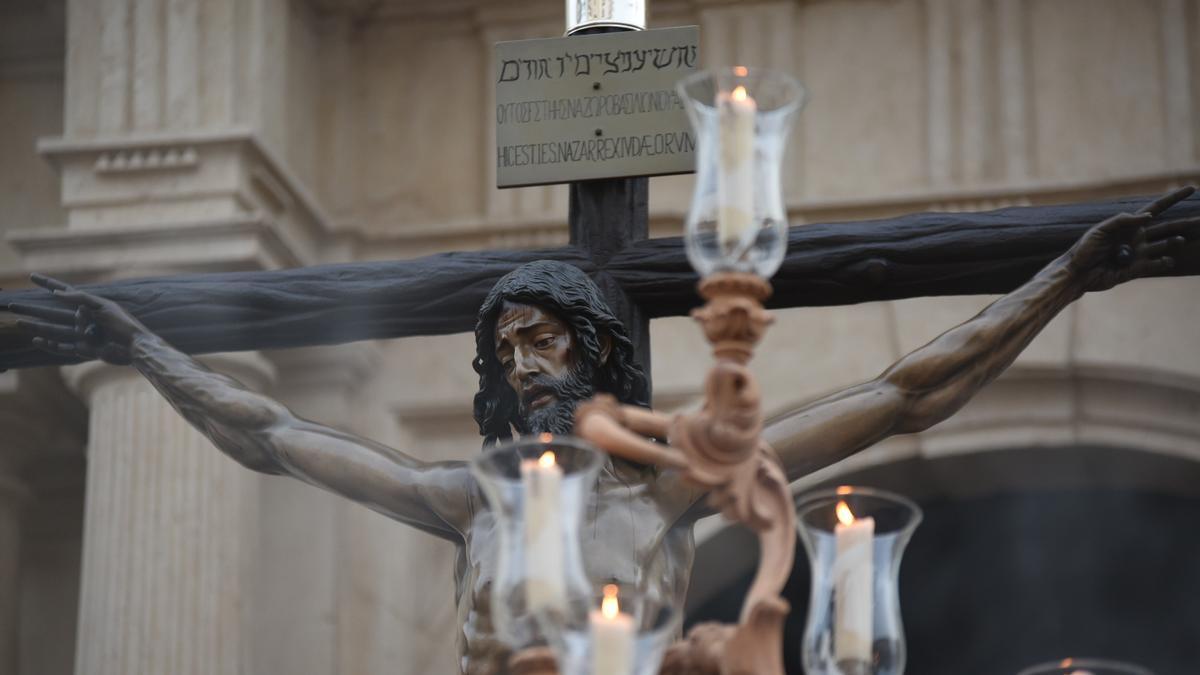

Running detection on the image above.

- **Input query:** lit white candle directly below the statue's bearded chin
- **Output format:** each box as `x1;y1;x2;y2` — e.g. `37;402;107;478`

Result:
521;450;566;613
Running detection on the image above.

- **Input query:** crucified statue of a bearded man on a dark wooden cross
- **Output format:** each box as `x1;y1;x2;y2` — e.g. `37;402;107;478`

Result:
0;2;1200;675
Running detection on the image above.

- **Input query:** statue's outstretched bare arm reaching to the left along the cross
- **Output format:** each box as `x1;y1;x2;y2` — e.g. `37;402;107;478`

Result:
10;275;473;539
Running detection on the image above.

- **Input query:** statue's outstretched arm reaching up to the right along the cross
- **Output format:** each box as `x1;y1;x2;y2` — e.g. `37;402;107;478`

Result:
763;189;1200;480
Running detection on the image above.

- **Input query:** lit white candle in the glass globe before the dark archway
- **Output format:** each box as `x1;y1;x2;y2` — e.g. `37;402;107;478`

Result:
833;501;875;663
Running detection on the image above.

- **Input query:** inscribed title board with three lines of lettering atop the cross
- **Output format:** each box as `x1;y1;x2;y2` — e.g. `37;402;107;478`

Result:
493;26;700;187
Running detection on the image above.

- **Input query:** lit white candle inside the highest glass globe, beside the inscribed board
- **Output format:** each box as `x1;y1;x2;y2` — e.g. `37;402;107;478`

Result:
716;76;758;250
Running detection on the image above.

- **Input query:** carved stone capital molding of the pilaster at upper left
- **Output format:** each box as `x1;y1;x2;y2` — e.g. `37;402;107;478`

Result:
29;129;341;268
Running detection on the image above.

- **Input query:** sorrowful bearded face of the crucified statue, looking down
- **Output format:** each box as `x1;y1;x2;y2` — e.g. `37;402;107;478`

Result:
494;301;595;434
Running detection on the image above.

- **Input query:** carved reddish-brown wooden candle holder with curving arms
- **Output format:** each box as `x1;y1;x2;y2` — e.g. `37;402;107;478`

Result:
511;273;796;675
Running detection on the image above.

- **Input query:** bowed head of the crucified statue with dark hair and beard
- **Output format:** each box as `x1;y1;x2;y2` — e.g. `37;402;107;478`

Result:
474;261;649;444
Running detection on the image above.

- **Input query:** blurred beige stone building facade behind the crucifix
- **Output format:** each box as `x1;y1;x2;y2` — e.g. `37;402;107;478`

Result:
0;0;1200;675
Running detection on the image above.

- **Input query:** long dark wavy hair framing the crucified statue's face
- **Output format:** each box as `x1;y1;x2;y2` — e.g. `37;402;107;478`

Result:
472;261;650;446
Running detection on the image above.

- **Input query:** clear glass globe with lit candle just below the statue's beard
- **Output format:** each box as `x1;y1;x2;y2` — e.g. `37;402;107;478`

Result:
470;434;602;650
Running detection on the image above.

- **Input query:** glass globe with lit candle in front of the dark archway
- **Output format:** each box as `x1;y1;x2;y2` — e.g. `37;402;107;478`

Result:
797;486;922;675
